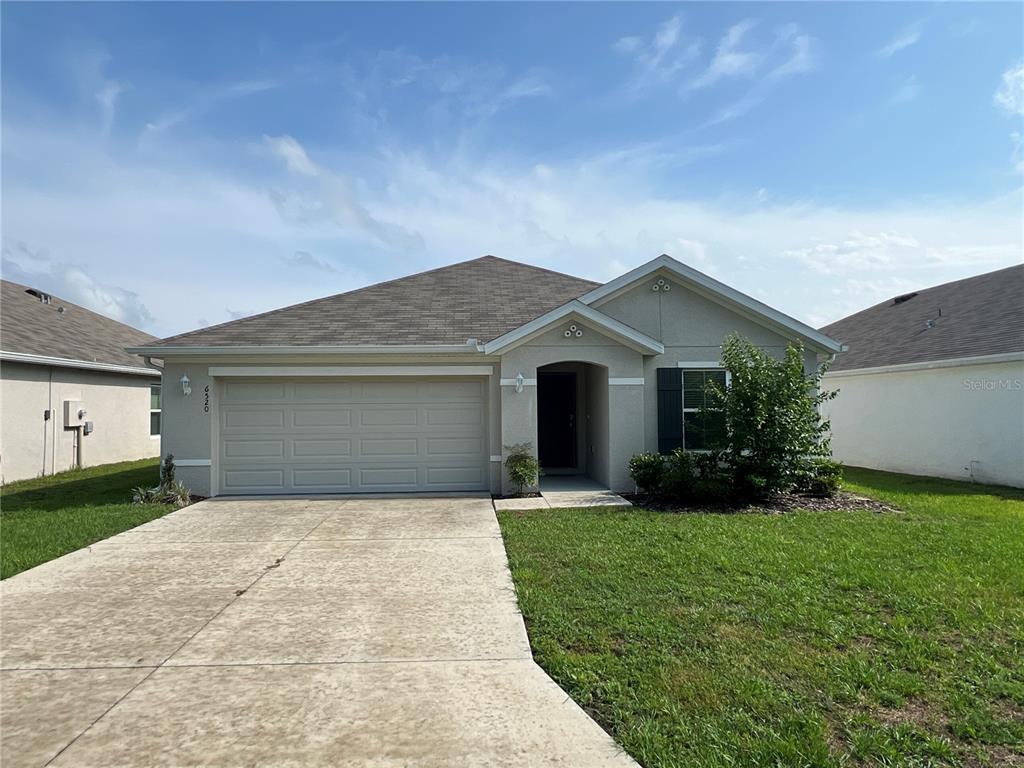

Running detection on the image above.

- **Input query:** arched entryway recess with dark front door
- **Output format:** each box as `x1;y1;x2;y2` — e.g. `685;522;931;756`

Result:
537;360;609;487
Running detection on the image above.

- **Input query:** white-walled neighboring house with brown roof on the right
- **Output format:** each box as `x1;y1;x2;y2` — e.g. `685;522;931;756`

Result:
821;265;1024;486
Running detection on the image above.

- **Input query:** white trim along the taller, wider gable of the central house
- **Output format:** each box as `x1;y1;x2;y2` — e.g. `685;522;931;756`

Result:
578;254;843;353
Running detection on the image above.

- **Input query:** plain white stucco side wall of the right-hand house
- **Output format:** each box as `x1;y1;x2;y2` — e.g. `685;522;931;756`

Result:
823;361;1024;487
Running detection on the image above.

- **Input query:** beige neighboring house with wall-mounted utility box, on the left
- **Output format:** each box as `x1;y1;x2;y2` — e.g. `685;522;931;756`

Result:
0;281;160;482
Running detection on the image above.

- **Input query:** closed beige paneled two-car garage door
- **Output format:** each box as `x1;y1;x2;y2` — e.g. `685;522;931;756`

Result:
218;378;487;494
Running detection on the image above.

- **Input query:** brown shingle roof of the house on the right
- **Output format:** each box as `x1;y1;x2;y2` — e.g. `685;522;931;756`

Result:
821;264;1024;371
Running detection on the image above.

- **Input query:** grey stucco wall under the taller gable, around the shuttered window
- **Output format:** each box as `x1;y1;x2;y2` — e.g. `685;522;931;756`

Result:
597;272;817;462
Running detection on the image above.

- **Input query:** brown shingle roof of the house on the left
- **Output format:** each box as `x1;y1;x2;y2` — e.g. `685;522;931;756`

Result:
0;281;156;372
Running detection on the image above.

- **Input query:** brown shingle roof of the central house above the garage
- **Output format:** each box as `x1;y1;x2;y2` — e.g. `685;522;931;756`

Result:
148;256;599;346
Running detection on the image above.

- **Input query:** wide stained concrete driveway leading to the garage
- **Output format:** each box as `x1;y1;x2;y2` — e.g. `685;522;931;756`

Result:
0;498;636;768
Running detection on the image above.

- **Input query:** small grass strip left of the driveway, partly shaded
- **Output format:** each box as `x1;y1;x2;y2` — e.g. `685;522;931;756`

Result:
0;459;165;579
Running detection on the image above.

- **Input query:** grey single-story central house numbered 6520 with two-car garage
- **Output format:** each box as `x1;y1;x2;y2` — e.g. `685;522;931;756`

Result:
130;256;840;495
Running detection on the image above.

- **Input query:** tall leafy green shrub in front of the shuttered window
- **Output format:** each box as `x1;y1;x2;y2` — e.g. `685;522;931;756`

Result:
707;334;836;498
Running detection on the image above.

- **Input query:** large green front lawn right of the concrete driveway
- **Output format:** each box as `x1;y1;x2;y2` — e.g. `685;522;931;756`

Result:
499;469;1024;768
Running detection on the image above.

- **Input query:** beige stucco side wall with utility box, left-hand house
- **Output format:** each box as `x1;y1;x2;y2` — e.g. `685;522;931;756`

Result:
0;362;160;482
